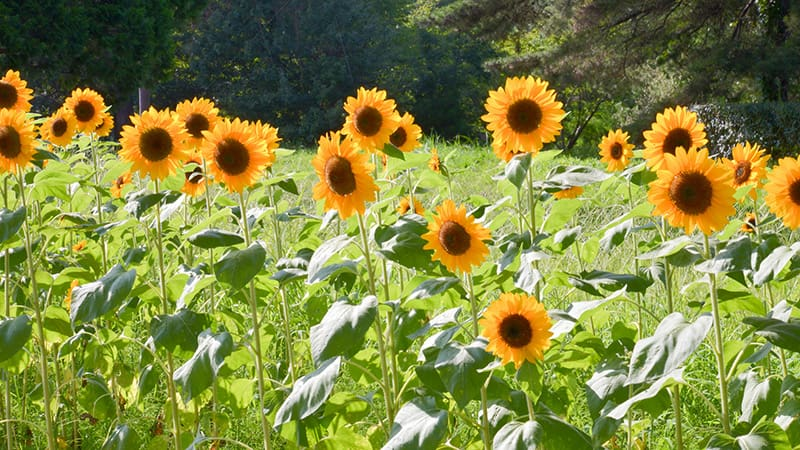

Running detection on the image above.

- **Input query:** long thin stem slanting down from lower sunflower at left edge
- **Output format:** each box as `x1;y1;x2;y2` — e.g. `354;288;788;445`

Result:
17;167;57;450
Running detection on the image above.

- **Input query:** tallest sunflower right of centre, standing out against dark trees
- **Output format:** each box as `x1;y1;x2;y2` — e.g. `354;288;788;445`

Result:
481;76;566;153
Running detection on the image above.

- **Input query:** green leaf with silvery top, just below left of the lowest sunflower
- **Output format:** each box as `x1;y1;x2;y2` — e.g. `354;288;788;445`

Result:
435;339;494;408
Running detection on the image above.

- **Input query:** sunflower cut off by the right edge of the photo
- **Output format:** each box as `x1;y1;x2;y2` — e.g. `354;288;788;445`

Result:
764;157;800;229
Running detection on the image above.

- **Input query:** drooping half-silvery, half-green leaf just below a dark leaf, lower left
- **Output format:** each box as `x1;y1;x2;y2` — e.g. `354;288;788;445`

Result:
172;330;233;403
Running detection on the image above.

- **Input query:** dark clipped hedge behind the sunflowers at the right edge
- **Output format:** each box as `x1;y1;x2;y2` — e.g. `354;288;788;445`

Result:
691;102;800;160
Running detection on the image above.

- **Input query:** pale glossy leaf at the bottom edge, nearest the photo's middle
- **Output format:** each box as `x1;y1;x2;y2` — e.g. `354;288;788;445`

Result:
381;397;447;450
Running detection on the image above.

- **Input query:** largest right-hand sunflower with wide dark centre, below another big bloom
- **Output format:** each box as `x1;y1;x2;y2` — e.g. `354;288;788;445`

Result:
647;147;735;234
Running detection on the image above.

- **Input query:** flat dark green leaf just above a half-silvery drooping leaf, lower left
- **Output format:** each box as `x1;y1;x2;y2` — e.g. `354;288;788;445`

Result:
150;309;208;352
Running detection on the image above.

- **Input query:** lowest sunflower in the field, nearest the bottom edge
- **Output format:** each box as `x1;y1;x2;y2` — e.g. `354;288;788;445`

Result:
478;293;553;369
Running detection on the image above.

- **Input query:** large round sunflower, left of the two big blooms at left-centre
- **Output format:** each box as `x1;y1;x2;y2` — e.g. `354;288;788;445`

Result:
119;106;189;180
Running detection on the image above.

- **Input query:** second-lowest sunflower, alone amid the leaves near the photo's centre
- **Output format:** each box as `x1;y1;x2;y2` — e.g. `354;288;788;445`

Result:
422;200;492;273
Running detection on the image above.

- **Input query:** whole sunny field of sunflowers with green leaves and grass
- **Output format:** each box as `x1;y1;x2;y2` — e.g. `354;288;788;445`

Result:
0;70;800;450
